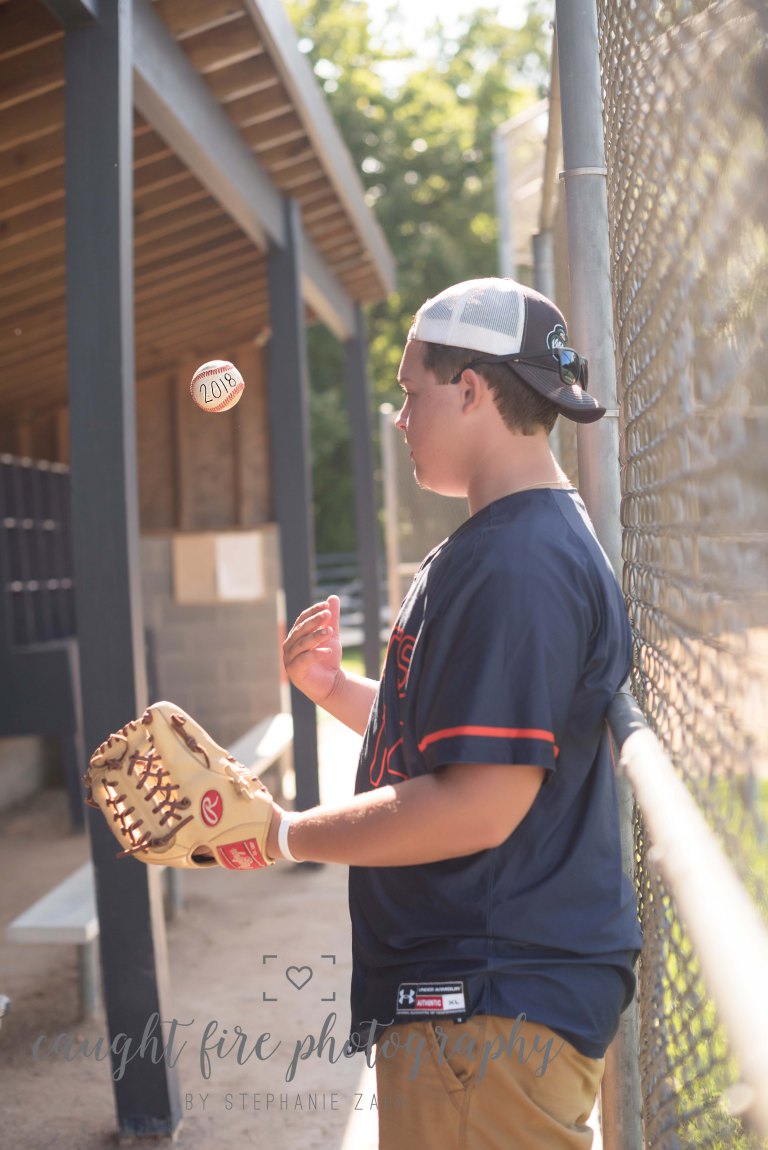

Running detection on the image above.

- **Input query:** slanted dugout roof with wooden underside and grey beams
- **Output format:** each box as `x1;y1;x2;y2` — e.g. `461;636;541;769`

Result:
0;0;393;427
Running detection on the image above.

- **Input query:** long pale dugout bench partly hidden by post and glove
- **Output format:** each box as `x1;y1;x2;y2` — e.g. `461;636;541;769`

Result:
6;713;293;1018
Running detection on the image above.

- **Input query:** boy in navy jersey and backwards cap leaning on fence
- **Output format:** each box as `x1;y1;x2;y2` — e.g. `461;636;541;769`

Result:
268;278;640;1150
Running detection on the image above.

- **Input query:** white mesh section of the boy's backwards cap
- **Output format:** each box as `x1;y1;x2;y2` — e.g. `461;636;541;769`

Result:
408;279;525;355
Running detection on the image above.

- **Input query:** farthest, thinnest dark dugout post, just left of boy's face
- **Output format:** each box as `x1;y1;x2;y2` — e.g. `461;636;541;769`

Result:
346;305;382;679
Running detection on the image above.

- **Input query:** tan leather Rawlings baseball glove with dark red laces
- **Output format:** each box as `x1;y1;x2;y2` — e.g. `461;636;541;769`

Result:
83;703;275;871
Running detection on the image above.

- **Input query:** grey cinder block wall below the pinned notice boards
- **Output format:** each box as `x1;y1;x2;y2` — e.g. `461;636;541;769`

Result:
141;524;281;745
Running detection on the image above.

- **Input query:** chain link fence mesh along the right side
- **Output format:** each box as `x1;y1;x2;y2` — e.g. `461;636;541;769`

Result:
597;0;768;1150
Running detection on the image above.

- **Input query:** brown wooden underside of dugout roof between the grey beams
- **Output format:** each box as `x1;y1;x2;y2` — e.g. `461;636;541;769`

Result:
0;0;387;416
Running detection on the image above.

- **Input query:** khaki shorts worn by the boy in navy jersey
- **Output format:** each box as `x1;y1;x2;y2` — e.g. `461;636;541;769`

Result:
376;1014;605;1150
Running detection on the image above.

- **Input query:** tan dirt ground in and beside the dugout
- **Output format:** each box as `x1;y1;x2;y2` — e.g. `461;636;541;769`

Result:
0;720;378;1150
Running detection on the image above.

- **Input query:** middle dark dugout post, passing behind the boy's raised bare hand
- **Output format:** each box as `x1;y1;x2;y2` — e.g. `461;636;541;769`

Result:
268;199;320;811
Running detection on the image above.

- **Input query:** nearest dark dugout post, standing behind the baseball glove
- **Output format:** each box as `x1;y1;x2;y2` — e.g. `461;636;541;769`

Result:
66;0;181;1137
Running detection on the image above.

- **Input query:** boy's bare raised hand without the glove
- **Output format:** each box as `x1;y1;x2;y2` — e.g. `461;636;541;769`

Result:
283;595;344;704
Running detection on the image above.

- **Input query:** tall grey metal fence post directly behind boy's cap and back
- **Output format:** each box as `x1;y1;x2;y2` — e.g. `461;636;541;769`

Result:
556;0;643;1150
